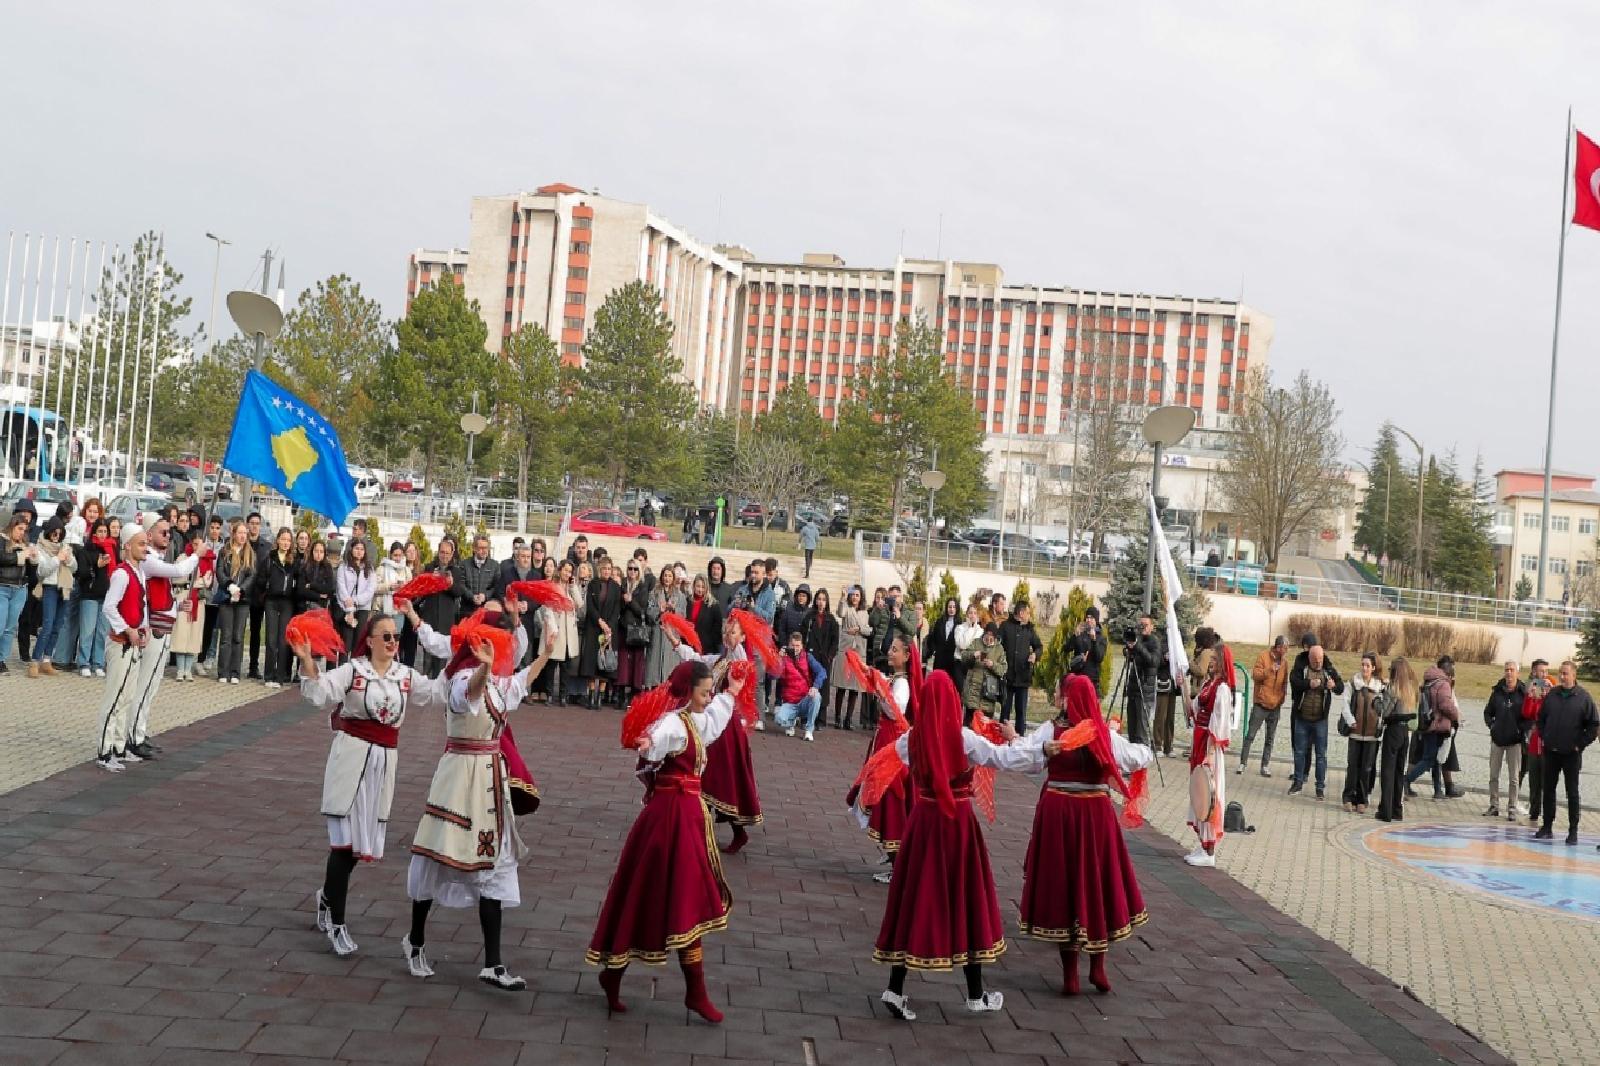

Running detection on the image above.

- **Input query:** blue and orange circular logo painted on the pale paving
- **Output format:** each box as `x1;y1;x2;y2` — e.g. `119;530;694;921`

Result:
1362;826;1600;920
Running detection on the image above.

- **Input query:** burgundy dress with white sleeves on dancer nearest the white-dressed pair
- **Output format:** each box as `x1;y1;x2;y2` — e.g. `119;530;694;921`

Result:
584;712;738;970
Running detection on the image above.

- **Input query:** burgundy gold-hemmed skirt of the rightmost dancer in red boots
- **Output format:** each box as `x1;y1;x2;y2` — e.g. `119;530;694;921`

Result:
1019;787;1149;954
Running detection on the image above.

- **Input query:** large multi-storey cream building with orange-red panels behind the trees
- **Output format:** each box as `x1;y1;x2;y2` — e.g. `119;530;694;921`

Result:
406;184;1272;527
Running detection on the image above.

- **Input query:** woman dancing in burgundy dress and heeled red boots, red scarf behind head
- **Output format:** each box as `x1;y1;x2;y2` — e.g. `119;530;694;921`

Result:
584;659;744;1024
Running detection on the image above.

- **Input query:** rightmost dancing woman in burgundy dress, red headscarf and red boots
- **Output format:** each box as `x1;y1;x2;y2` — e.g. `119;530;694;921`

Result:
1019;674;1154;996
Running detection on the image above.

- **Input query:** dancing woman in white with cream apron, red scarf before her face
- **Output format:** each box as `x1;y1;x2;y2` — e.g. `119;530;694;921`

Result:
403;611;549;991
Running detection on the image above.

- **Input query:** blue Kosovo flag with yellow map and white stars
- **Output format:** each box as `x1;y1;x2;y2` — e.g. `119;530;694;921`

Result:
222;370;355;525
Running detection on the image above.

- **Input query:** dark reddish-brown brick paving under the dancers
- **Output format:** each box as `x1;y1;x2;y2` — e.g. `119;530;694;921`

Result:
0;685;1507;1066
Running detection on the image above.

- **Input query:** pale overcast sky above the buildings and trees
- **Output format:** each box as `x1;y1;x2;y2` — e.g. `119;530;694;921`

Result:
0;0;1600;472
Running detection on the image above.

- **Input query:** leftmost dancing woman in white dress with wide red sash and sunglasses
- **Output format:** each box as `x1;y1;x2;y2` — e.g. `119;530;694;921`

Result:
290;615;446;953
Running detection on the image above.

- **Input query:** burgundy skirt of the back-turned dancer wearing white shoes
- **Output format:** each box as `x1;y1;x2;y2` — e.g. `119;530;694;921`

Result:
872;799;1005;970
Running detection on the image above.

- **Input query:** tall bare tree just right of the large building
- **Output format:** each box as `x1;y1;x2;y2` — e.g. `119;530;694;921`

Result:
1219;370;1349;570
